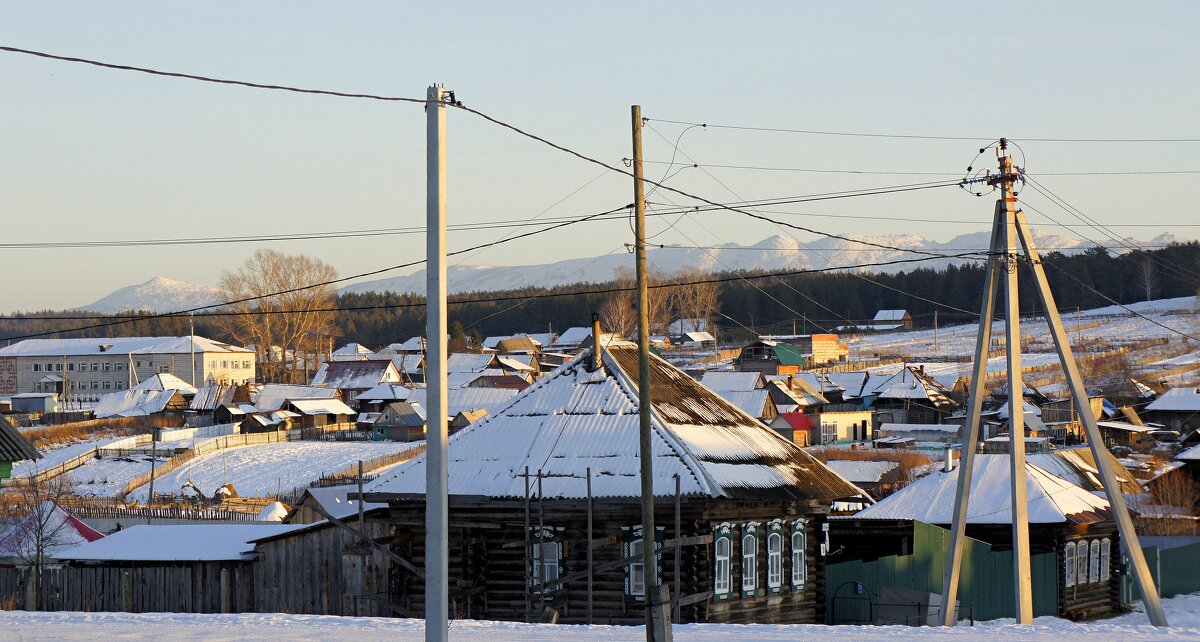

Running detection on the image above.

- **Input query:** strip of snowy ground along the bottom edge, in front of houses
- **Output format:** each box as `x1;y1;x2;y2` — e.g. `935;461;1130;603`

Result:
0;595;1200;642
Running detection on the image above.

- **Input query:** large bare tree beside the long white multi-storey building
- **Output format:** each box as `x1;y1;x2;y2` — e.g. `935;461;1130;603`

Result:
218;250;337;382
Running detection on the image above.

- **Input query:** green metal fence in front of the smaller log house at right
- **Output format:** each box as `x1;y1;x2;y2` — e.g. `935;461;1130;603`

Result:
826;522;1058;619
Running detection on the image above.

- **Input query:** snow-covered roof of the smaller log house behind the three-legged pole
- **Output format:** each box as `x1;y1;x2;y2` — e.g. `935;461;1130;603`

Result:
848;454;1111;524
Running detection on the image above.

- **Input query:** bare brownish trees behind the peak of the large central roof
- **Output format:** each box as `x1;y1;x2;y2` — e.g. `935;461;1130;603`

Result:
599;268;720;336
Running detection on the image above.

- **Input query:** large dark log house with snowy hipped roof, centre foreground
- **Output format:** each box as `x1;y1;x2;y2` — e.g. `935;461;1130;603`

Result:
366;343;862;624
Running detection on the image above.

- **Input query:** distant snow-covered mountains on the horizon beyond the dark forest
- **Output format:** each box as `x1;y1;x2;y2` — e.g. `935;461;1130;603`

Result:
73;229;1184;313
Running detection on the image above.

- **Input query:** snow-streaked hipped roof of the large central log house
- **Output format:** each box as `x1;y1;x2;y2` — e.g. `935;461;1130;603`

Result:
368;346;860;500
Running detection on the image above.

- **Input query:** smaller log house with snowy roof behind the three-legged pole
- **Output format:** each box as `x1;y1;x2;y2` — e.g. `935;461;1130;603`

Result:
830;455;1122;619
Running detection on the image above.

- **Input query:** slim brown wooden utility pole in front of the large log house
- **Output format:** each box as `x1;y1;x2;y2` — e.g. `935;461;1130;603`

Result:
633;104;671;642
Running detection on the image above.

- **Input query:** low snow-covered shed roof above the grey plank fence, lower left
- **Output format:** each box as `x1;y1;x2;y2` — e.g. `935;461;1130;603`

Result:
55;524;304;562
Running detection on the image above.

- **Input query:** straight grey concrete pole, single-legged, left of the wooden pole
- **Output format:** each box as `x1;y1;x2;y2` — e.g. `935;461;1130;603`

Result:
425;85;452;642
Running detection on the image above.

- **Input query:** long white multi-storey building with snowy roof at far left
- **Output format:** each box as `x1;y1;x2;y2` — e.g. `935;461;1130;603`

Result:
0;336;254;401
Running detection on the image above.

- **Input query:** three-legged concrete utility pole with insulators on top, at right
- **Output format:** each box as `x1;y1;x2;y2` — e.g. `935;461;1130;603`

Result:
941;138;1166;626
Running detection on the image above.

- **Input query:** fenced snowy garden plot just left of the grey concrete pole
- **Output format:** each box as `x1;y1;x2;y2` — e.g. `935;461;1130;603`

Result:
126;442;413;502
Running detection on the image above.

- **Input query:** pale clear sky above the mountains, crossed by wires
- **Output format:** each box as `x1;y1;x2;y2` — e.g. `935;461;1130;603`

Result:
0;1;1200;311
